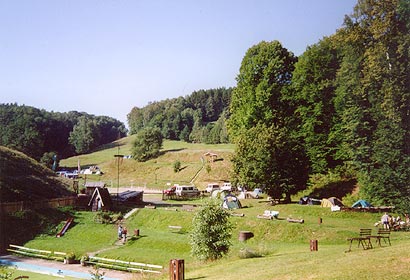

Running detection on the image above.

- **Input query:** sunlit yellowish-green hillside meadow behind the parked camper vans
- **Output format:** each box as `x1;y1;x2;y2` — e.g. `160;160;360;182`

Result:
60;136;234;189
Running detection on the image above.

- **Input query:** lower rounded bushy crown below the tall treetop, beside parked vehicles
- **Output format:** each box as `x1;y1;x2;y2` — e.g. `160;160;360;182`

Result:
232;124;308;201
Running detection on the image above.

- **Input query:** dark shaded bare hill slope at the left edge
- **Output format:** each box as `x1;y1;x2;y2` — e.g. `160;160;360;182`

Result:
0;146;72;202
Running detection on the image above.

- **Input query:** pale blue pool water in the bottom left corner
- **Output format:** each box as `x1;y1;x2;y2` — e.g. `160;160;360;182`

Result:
0;259;120;280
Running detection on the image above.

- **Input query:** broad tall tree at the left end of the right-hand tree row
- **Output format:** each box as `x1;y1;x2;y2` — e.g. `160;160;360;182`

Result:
228;41;307;198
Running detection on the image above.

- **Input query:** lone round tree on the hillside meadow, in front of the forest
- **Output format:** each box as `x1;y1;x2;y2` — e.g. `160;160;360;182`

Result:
132;127;163;162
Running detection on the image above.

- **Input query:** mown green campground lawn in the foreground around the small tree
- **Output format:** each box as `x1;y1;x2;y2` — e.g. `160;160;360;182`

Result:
20;200;410;279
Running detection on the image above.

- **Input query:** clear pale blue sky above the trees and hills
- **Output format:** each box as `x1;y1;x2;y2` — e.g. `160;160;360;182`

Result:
0;0;357;124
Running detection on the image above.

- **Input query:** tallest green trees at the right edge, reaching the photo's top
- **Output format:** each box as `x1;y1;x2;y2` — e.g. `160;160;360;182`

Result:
336;0;410;211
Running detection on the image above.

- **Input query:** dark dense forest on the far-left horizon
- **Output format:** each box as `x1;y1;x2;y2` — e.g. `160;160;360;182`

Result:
0;104;127;162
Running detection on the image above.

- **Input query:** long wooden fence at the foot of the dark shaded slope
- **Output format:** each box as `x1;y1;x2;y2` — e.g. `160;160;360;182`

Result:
0;196;77;213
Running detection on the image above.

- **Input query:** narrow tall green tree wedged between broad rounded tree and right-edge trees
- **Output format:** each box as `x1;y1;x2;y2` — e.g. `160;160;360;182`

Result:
288;37;342;173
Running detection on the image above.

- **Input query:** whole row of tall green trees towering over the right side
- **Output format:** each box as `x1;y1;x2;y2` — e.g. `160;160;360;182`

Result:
228;0;410;211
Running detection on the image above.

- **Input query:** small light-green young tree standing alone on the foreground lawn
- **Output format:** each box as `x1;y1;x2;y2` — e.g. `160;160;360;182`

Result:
190;199;232;261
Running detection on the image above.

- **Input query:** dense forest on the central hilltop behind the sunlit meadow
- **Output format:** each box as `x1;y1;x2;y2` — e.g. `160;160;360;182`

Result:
127;88;232;144
